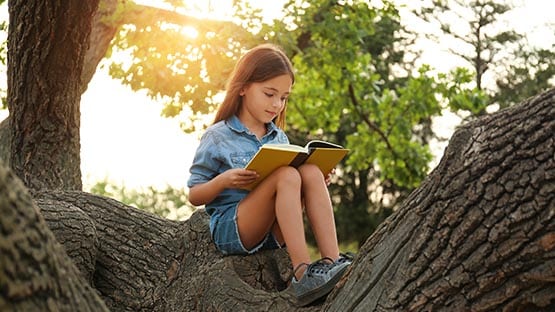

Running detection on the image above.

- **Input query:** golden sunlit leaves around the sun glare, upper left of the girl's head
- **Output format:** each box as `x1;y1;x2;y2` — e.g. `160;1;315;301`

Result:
109;1;260;132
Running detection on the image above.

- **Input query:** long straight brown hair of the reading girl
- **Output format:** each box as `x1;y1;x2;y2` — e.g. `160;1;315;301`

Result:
214;43;295;129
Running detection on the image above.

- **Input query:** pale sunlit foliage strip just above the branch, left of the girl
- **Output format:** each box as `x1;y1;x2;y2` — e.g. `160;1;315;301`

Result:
89;180;195;220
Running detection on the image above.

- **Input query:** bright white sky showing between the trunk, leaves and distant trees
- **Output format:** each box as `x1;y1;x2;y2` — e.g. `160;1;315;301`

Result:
0;0;555;190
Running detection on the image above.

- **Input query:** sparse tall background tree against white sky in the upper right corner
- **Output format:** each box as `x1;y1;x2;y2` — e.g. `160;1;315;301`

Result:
416;0;555;114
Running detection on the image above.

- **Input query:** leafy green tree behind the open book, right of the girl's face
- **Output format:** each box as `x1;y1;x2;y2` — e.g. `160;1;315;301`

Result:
265;0;486;244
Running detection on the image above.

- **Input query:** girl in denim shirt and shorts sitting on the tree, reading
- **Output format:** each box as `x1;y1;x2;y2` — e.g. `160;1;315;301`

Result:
187;44;351;306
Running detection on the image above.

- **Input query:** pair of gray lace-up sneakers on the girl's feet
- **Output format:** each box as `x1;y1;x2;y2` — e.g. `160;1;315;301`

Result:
291;258;349;307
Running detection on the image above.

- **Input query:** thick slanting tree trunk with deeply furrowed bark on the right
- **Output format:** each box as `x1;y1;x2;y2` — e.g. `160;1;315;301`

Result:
325;89;555;311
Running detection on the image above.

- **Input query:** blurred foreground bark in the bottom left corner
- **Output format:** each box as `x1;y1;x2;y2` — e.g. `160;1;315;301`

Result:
0;162;107;311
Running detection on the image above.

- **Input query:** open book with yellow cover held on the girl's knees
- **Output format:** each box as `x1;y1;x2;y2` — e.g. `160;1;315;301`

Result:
245;140;349;190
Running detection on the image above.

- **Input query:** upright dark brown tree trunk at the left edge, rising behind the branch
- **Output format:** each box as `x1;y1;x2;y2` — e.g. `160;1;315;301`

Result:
8;0;98;190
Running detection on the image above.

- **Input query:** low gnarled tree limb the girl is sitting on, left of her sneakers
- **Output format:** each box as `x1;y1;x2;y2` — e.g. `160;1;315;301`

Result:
35;192;300;311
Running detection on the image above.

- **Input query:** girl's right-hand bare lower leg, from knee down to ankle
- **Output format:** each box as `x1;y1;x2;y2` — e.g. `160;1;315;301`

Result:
299;164;339;260
